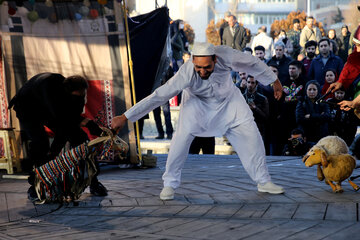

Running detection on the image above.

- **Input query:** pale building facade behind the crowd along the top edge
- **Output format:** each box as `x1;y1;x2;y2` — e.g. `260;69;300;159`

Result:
128;0;352;42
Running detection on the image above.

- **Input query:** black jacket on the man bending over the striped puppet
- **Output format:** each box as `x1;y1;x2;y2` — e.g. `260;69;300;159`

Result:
9;73;85;128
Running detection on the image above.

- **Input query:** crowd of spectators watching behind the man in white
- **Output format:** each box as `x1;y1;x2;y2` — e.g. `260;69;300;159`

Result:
222;16;360;155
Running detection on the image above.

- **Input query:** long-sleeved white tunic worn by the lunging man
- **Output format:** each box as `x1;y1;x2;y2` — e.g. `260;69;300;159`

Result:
125;46;277;137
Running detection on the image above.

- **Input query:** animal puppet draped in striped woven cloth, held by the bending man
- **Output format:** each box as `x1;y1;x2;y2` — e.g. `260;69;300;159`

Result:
35;128;129;204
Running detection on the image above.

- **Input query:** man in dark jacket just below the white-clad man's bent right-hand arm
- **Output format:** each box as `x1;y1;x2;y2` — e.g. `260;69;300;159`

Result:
243;75;269;140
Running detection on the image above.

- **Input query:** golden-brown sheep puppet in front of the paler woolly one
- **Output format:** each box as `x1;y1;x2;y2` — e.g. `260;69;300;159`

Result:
303;148;360;193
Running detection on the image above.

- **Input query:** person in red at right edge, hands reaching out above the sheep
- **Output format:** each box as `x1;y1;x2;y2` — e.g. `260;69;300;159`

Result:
328;26;360;110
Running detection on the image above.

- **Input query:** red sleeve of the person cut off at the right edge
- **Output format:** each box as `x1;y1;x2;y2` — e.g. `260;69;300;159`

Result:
339;52;360;89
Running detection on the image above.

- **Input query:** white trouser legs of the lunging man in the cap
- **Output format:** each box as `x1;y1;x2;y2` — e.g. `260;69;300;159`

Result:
162;119;271;188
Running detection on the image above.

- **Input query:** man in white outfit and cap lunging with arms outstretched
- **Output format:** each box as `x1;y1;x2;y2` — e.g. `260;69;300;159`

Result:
111;43;284;200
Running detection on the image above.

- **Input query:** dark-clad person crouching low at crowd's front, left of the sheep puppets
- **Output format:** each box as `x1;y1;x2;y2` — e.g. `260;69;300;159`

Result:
282;128;315;156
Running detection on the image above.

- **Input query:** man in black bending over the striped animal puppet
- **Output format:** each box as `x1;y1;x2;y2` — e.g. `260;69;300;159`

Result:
9;73;107;201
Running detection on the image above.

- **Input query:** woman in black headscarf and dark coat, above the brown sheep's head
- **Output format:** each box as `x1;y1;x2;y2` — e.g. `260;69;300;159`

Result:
296;80;330;142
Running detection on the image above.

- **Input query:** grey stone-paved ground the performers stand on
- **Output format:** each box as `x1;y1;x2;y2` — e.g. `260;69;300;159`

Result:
0;155;360;240
